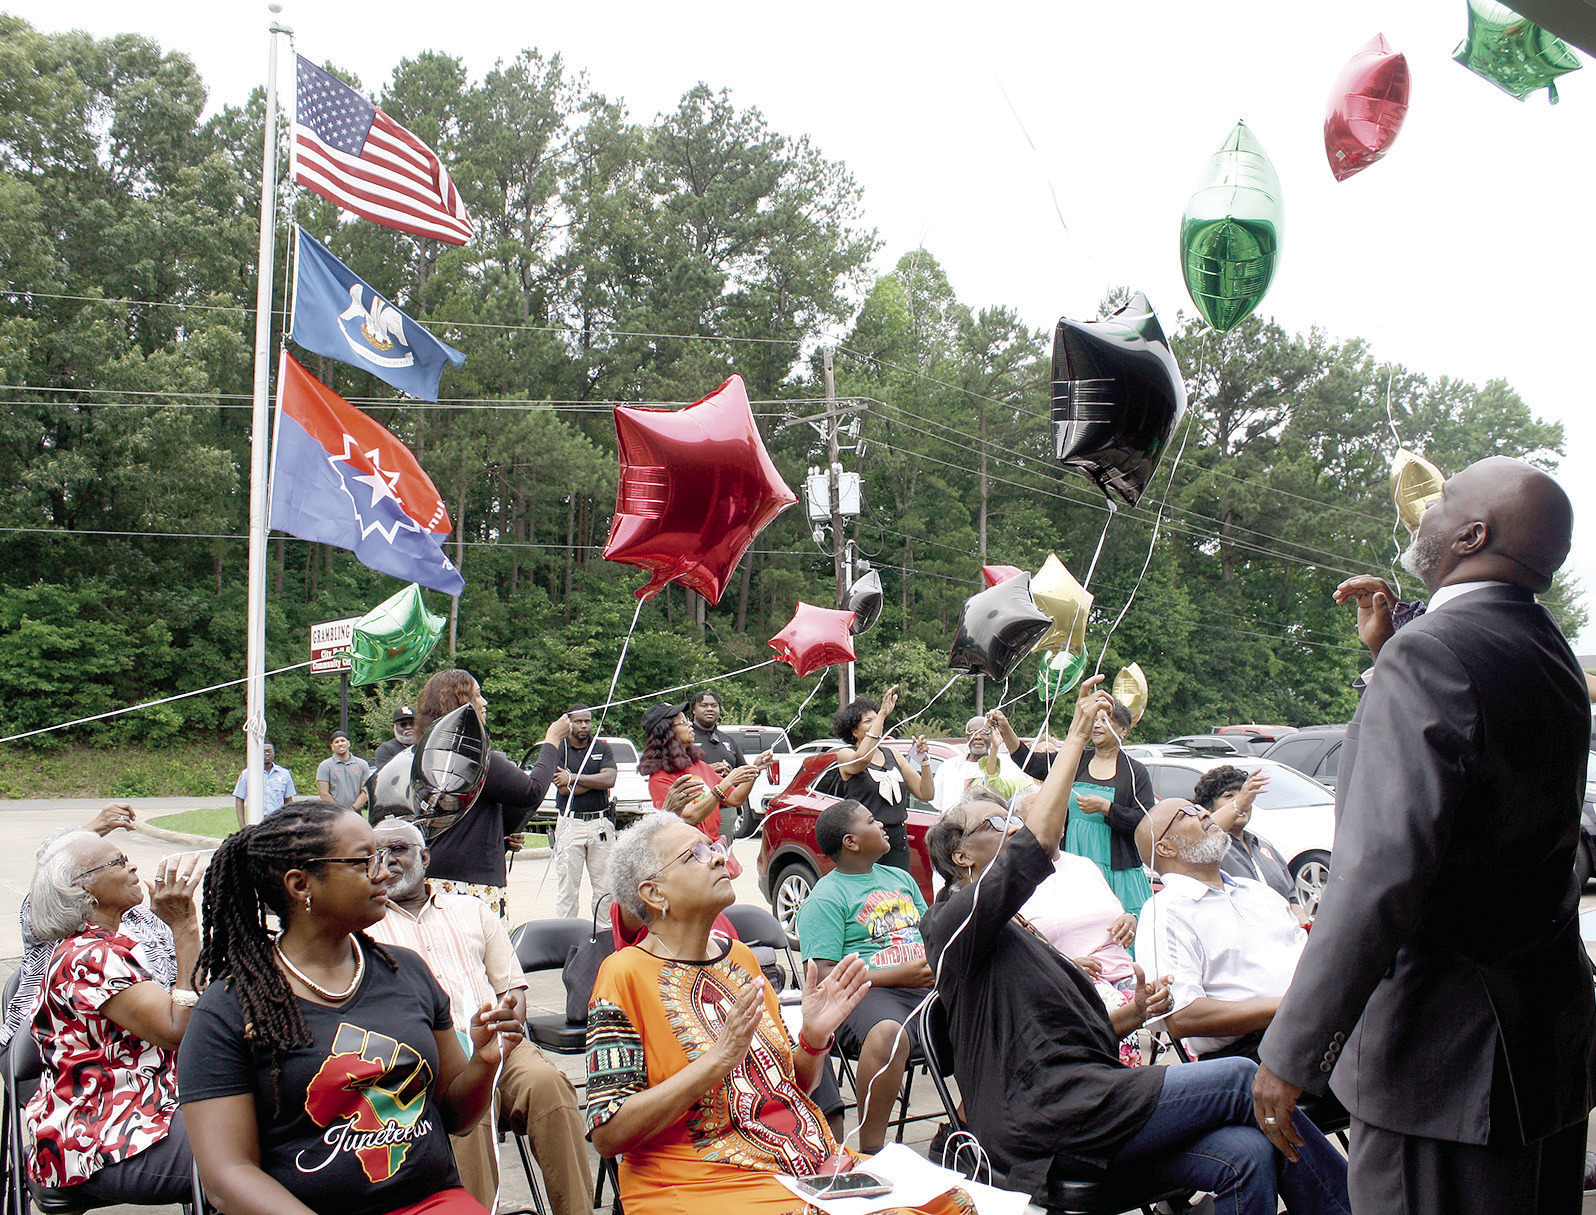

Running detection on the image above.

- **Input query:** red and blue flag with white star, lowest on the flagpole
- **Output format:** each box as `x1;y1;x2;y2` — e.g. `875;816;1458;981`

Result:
271;351;466;596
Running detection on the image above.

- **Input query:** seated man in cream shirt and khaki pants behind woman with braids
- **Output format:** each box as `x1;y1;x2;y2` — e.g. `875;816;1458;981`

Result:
367;819;594;1215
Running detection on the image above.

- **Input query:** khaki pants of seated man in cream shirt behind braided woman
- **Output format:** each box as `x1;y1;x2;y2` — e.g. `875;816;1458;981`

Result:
450;1041;594;1215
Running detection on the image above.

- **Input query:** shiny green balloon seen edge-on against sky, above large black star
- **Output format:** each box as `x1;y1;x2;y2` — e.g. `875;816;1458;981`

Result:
1181;123;1282;334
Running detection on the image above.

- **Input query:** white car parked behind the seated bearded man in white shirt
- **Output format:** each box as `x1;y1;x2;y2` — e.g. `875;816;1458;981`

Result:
1143;755;1336;915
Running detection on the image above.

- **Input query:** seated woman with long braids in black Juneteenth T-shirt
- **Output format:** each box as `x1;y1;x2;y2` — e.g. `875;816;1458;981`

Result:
177;801;520;1215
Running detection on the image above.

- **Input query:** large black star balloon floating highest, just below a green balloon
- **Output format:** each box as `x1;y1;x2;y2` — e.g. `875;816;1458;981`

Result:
1053;291;1186;506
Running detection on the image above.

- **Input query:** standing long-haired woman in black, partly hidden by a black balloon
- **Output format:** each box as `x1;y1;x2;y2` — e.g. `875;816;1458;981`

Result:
405;667;571;918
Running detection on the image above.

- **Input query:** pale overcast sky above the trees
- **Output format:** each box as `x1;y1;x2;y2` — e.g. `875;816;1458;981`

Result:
12;0;1596;651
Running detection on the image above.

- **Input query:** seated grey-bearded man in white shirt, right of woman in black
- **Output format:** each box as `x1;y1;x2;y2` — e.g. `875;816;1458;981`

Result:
1136;798;1307;1060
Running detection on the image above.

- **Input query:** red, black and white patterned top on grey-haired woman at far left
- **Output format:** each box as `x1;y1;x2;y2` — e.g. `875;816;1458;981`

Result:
24;924;177;1186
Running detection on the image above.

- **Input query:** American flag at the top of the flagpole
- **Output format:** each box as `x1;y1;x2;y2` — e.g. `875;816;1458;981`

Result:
294;56;471;244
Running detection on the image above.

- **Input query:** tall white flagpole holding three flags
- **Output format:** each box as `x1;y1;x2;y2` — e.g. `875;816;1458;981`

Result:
244;5;292;822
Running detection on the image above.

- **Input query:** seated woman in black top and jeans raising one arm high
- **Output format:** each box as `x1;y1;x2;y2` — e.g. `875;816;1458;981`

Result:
921;677;1350;1215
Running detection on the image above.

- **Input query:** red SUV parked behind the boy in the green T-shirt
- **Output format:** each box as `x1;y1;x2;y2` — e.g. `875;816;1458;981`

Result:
760;739;958;936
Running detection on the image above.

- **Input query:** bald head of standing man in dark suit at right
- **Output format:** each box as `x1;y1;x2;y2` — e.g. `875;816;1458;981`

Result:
1414;455;1574;594
